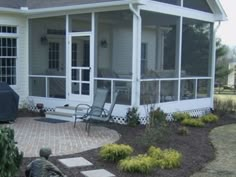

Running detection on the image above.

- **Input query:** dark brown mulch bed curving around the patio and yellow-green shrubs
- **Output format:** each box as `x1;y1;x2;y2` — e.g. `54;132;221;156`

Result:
20;115;236;177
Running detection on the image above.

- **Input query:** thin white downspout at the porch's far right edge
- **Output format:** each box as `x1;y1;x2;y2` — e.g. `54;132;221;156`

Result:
211;21;221;110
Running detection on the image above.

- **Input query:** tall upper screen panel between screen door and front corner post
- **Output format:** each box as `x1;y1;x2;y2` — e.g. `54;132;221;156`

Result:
96;10;133;79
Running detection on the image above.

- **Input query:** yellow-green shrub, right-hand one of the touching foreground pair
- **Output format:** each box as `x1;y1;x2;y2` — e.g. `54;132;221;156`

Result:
148;146;182;169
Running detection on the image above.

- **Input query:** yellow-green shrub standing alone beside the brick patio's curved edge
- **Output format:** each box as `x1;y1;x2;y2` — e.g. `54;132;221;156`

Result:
99;144;133;162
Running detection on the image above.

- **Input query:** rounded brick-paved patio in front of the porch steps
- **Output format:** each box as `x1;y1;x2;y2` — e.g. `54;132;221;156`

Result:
5;118;120;157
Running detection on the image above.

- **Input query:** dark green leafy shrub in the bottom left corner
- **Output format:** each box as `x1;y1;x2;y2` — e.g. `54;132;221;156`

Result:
0;127;23;177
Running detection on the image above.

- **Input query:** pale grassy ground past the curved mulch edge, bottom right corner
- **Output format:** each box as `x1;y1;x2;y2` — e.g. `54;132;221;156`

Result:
192;124;236;177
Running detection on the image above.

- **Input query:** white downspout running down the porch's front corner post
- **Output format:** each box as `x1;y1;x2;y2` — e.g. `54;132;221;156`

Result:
129;3;142;107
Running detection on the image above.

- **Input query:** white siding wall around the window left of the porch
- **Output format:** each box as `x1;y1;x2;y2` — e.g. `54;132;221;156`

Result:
0;13;28;101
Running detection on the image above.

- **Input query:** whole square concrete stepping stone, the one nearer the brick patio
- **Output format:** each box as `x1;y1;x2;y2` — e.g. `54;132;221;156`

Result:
59;157;93;168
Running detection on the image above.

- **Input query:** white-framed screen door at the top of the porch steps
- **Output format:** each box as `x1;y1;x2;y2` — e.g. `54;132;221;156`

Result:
69;34;92;101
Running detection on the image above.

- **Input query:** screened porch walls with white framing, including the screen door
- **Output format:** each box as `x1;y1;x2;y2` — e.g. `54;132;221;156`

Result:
29;7;213;106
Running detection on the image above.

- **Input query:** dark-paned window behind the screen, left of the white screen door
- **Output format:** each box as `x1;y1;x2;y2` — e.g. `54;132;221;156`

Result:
48;42;59;70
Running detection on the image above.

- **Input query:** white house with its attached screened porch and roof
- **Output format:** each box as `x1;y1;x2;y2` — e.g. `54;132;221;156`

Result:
0;0;226;121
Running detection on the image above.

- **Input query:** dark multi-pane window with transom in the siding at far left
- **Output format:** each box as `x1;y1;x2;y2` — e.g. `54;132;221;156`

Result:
0;36;17;85
